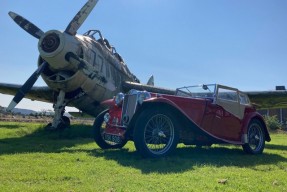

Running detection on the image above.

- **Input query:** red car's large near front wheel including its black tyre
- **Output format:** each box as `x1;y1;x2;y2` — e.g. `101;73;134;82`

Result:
134;108;179;158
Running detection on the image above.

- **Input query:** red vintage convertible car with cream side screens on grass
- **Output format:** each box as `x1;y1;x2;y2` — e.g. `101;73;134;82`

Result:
94;84;271;157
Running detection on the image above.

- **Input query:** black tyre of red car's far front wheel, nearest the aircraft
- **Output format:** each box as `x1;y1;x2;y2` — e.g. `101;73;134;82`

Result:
93;110;127;149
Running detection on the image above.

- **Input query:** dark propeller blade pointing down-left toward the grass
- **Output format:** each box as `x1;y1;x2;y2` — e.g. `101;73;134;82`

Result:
6;61;48;111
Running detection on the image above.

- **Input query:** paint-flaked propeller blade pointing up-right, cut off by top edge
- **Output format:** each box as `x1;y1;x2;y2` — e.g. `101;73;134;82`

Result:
65;0;98;35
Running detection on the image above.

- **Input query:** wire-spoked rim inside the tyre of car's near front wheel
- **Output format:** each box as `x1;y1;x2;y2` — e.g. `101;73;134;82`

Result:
144;114;174;155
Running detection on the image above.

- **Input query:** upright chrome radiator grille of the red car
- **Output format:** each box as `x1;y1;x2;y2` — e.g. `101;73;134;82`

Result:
122;94;137;125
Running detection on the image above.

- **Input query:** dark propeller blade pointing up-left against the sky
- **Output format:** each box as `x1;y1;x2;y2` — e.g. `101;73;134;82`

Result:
9;11;44;39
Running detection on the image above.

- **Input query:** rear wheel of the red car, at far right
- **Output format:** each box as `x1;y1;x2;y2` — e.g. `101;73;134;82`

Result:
242;120;265;154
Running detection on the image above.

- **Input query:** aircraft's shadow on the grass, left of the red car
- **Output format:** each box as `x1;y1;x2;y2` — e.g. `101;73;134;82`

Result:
0;124;93;155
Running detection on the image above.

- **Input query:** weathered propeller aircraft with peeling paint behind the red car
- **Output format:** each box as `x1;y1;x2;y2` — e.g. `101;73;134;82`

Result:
0;0;287;129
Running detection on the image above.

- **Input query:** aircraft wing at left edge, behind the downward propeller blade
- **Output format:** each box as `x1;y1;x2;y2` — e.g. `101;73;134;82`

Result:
0;83;54;103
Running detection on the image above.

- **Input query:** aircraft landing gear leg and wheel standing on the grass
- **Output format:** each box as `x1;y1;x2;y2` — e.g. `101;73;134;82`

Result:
46;90;71;130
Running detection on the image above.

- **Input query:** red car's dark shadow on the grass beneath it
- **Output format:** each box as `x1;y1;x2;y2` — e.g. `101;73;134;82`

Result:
87;146;287;174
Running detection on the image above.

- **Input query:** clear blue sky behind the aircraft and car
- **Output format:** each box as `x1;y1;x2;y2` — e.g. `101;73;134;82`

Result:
0;0;287;110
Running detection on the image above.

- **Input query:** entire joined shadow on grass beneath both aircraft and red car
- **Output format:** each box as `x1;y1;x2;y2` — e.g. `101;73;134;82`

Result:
0;122;287;174
